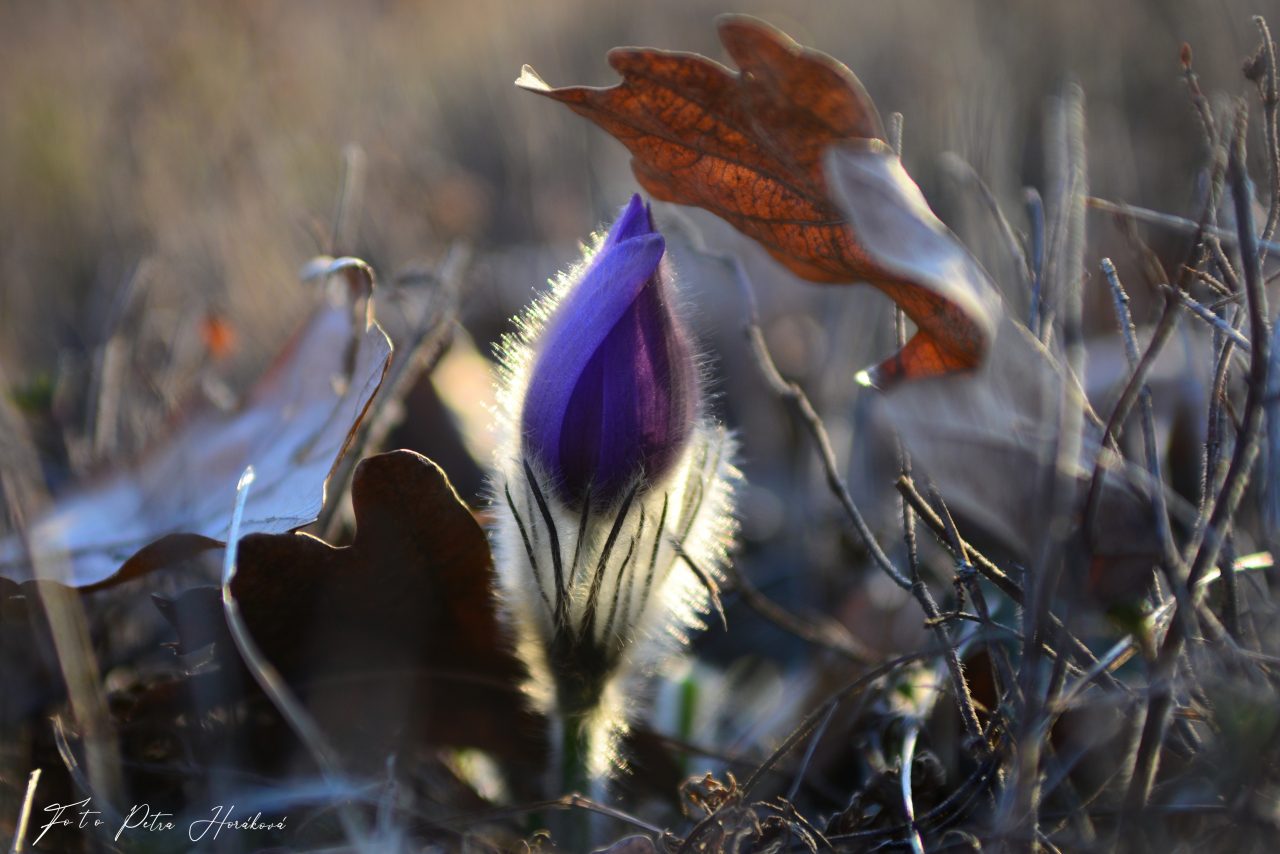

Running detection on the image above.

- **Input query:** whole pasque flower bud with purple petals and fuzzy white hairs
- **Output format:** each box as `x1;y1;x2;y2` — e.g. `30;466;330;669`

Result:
493;196;739;788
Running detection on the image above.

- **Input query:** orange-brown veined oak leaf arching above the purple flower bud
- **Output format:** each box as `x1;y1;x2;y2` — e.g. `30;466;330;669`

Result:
516;15;1000;387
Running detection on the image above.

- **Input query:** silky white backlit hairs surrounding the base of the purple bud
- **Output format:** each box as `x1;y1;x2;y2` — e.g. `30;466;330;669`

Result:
490;230;741;780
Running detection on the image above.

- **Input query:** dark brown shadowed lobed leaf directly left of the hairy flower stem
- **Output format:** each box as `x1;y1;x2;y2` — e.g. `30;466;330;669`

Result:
157;451;539;758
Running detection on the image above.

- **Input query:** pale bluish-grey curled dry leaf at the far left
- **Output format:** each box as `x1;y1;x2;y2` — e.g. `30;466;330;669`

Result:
0;259;392;588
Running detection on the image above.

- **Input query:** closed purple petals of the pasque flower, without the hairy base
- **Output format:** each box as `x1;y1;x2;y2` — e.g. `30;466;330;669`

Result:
521;196;698;507
